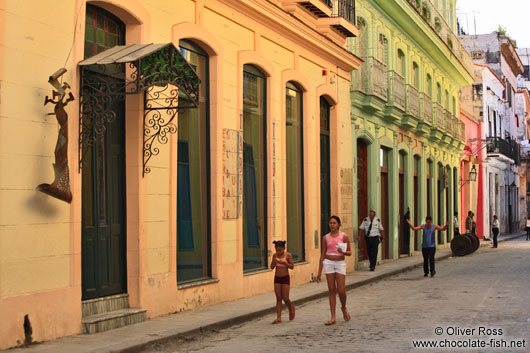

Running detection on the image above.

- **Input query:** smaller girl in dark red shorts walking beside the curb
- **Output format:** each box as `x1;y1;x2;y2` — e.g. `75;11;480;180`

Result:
271;240;294;324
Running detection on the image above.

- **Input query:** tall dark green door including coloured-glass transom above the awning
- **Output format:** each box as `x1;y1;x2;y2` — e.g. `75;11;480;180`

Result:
81;5;126;300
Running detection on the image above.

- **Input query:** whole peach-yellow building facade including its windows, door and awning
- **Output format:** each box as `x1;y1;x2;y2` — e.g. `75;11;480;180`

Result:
0;0;362;349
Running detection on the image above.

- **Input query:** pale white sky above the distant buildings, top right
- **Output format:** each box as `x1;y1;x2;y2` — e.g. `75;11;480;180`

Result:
456;0;530;48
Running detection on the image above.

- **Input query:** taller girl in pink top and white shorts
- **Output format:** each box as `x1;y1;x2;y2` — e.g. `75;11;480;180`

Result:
317;216;351;325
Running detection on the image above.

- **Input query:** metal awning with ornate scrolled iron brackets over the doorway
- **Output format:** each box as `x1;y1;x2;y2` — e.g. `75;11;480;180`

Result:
78;43;200;173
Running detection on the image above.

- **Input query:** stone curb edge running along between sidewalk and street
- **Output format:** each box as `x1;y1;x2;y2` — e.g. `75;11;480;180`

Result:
111;233;525;353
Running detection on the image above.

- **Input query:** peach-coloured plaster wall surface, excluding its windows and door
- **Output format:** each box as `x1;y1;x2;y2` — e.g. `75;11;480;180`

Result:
0;0;360;349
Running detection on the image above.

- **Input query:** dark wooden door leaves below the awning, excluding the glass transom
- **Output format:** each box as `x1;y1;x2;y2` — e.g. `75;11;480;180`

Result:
81;97;126;300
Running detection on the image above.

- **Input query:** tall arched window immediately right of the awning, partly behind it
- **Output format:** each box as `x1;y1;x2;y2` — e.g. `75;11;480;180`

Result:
177;40;211;283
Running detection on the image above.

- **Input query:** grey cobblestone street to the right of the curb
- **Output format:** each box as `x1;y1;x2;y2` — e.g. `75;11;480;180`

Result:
143;238;530;352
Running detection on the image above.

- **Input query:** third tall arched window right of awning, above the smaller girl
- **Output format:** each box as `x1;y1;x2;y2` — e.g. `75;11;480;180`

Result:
285;82;305;261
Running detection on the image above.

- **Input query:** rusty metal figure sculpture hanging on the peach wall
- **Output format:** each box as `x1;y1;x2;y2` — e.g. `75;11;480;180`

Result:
37;68;74;203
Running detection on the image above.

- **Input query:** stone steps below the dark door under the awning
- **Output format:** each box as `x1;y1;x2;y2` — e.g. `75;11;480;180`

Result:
82;309;147;334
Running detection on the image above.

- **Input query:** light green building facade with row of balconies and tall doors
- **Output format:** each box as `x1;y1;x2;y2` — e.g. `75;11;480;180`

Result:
349;0;473;267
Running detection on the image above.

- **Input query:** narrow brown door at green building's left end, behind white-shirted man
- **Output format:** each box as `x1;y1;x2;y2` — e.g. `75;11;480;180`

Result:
357;139;368;261
